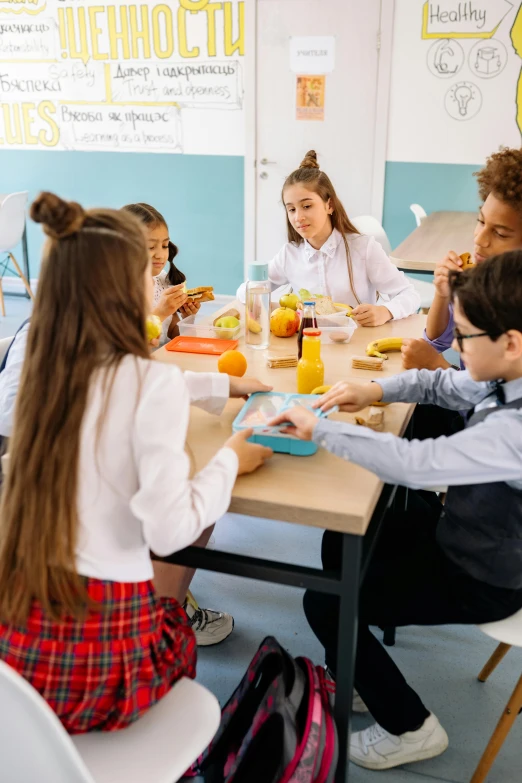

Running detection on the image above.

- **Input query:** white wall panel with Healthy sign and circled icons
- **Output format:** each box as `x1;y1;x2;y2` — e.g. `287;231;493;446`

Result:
387;0;522;164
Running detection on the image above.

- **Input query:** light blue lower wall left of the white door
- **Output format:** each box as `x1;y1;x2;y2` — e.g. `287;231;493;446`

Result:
0;150;244;294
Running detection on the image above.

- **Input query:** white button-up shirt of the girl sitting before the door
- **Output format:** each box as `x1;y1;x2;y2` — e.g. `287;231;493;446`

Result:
237;229;420;319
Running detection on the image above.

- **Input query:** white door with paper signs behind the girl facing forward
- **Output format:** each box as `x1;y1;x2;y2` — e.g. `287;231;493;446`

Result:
250;0;391;262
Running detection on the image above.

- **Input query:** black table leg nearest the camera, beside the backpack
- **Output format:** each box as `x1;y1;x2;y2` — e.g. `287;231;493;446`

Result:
335;533;362;783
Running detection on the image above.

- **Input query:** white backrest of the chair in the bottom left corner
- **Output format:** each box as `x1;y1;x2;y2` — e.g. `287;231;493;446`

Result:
0;661;95;783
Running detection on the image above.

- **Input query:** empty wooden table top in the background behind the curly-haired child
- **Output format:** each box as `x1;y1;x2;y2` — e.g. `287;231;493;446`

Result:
390;212;477;272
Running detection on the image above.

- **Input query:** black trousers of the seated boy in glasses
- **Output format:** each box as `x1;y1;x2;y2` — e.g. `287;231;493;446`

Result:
304;492;522;734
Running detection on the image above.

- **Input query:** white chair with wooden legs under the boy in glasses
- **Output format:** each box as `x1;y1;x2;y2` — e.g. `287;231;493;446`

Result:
471;609;522;783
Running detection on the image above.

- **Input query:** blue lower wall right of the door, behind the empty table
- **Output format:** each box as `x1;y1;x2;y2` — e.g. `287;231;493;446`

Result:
383;161;481;253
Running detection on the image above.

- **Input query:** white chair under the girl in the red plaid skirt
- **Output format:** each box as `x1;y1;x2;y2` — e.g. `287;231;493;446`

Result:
0;661;220;783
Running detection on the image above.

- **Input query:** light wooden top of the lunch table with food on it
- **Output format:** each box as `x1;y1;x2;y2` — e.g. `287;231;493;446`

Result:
155;302;426;535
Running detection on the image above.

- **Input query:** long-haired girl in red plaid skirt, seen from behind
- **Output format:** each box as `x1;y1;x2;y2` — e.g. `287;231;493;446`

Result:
0;193;270;733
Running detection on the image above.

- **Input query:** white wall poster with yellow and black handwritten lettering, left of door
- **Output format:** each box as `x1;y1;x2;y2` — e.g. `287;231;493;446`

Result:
0;0;245;155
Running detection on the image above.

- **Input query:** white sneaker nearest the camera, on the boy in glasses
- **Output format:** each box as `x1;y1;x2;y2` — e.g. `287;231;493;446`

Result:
349;713;448;769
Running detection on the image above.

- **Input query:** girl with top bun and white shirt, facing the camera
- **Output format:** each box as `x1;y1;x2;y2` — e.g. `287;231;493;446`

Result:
238;150;420;326
